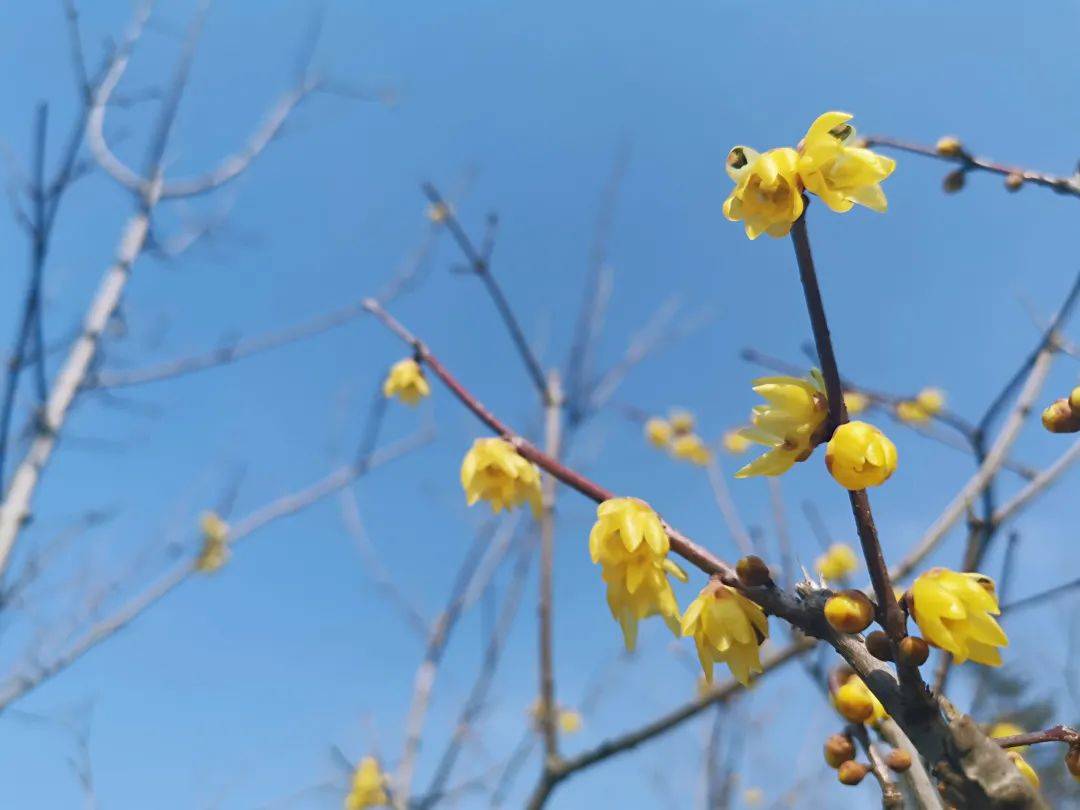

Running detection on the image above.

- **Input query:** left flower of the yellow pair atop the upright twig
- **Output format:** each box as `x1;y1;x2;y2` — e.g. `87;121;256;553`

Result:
724;146;804;239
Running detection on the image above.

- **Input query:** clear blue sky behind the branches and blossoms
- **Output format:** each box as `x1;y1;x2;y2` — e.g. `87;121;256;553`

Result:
0;0;1080;809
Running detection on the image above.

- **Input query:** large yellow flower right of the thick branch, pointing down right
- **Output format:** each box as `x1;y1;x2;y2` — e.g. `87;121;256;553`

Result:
909;568;1009;666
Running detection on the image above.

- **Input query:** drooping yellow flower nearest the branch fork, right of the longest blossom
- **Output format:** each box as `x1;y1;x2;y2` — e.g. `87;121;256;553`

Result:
683;580;769;686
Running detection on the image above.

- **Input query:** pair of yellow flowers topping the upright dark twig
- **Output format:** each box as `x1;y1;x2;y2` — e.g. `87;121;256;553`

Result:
724;112;896;239
